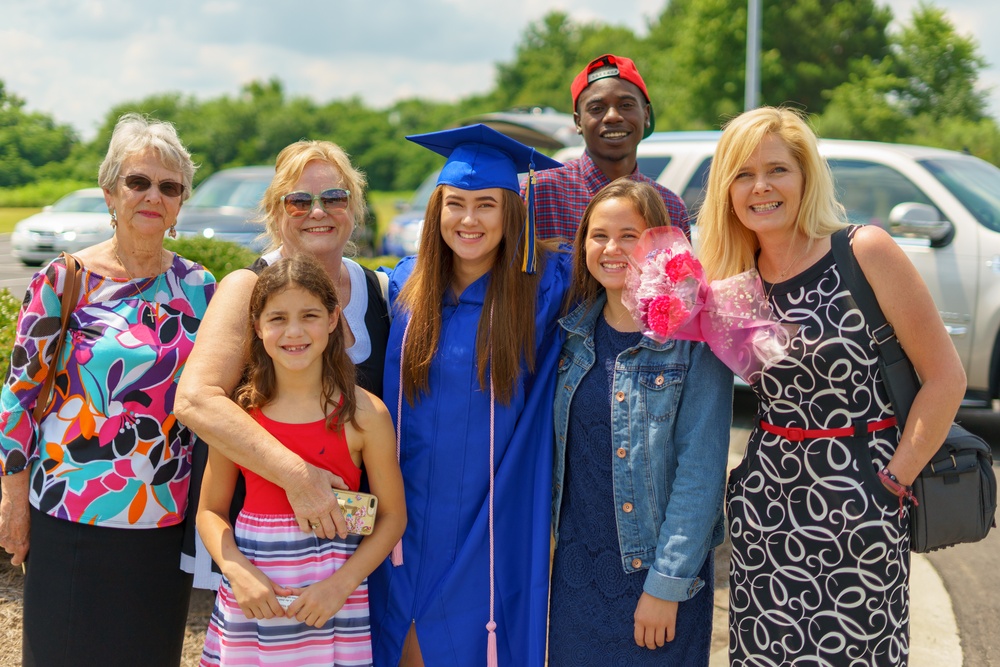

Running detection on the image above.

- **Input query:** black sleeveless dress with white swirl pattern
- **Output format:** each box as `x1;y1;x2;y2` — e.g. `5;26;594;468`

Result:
726;240;910;667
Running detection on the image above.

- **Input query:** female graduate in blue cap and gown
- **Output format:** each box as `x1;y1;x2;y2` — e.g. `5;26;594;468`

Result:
369;125;569;667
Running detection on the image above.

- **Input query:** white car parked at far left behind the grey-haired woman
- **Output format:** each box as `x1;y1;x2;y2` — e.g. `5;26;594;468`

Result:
10;188;114;266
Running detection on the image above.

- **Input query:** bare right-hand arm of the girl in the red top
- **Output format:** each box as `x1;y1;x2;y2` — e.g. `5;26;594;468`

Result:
288;387;406;627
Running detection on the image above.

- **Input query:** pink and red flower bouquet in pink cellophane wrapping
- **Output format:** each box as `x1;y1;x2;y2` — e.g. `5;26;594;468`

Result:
622;227;792;384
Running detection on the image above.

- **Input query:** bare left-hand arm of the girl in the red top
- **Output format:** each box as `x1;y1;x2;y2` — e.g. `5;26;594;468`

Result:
197;450;291;618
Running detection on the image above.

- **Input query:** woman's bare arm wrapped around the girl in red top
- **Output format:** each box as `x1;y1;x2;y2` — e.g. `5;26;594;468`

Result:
174;270;347;537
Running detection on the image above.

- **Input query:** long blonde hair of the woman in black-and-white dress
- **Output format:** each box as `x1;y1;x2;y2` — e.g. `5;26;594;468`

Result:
698;107;847;280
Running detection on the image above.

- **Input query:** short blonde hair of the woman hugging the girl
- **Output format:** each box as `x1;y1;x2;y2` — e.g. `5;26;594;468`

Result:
260;140;367;252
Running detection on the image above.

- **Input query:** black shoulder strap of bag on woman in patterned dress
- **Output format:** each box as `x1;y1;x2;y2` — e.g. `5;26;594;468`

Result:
830;227;920;429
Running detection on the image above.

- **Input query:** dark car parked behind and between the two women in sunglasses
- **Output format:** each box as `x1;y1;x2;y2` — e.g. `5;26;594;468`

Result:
177;166;375;255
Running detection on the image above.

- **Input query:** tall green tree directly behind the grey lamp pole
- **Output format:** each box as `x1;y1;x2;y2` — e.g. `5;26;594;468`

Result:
644;0;892;129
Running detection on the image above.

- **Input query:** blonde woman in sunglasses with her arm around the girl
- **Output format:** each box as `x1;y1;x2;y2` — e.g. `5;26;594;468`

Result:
177;141;389;588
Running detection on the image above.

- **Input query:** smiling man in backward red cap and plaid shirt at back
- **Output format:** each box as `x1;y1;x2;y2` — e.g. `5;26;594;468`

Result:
522;53;690;239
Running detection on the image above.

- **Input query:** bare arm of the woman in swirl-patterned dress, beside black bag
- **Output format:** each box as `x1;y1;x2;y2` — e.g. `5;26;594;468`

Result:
853;226;966;485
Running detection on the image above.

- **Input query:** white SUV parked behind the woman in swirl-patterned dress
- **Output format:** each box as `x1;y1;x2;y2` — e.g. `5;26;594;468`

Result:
554;132;1000;404
